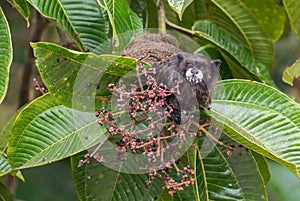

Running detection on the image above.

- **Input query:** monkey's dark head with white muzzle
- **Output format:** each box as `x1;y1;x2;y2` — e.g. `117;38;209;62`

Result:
167;52;221;90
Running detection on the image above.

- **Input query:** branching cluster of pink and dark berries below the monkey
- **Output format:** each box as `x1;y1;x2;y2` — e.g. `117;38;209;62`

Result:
78;57;220;195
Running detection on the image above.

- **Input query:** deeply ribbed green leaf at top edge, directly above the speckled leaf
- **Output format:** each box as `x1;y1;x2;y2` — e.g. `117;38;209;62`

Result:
28;0;109;54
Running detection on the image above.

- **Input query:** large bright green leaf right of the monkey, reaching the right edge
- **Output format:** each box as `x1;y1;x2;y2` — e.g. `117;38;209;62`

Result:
210;80;300;176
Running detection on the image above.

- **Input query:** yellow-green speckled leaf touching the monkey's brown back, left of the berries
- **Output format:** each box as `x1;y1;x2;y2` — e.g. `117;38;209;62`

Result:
32;43;136;109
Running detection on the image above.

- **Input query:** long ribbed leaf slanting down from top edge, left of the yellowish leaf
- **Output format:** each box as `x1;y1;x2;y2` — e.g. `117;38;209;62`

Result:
209;0;274;69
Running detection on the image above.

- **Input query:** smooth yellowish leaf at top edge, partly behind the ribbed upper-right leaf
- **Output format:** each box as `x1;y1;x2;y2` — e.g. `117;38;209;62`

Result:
242;0;285;43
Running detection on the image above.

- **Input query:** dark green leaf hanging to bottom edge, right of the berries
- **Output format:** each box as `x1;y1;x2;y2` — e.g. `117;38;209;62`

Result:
158;135;267;201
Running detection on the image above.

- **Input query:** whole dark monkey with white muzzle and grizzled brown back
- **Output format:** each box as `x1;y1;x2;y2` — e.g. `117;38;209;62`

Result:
121;34;220;124
